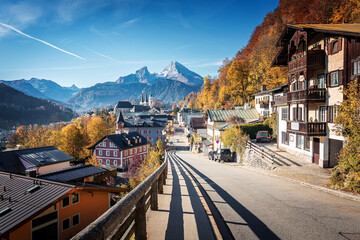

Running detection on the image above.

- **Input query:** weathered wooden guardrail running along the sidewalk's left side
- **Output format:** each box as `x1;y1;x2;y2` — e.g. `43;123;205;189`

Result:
72;152;168;240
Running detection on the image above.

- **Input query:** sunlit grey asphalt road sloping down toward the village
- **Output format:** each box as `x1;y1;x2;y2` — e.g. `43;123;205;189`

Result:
172;128;360;239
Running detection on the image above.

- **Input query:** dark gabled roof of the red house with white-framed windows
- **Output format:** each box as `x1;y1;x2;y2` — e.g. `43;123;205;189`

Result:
88;132;147;150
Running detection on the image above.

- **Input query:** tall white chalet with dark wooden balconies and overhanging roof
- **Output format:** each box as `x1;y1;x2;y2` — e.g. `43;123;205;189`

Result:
273;24;360;167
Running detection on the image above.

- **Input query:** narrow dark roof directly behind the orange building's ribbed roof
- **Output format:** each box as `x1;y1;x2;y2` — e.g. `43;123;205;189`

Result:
40;165;106;182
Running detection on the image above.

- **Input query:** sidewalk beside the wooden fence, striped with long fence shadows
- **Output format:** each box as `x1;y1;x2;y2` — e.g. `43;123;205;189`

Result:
146;151;216;240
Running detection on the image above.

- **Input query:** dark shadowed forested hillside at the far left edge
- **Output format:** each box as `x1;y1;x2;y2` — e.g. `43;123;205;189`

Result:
0;83;75;129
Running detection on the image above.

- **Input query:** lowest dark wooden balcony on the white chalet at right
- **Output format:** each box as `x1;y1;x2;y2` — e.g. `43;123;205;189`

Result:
287;122;326;136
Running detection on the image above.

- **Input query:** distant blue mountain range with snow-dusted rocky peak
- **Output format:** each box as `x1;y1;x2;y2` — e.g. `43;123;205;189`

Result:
0;61;203;110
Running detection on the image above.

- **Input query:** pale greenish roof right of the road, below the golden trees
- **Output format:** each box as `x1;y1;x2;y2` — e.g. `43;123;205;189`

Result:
207;108;259;122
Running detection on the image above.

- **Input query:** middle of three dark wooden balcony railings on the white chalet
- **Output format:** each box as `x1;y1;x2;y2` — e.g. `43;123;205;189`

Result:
287;88;326;102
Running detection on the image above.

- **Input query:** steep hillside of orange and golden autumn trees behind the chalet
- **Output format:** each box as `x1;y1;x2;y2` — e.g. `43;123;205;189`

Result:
183;0;360;110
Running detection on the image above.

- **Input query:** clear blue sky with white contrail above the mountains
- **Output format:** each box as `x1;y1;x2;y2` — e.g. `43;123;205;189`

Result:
0;0;278;87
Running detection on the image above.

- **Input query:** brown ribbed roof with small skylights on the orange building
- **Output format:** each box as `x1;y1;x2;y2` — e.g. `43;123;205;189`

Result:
0;172;74;238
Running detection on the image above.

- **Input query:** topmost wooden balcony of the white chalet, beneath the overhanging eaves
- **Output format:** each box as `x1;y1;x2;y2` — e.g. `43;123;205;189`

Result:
288;50;325;74
